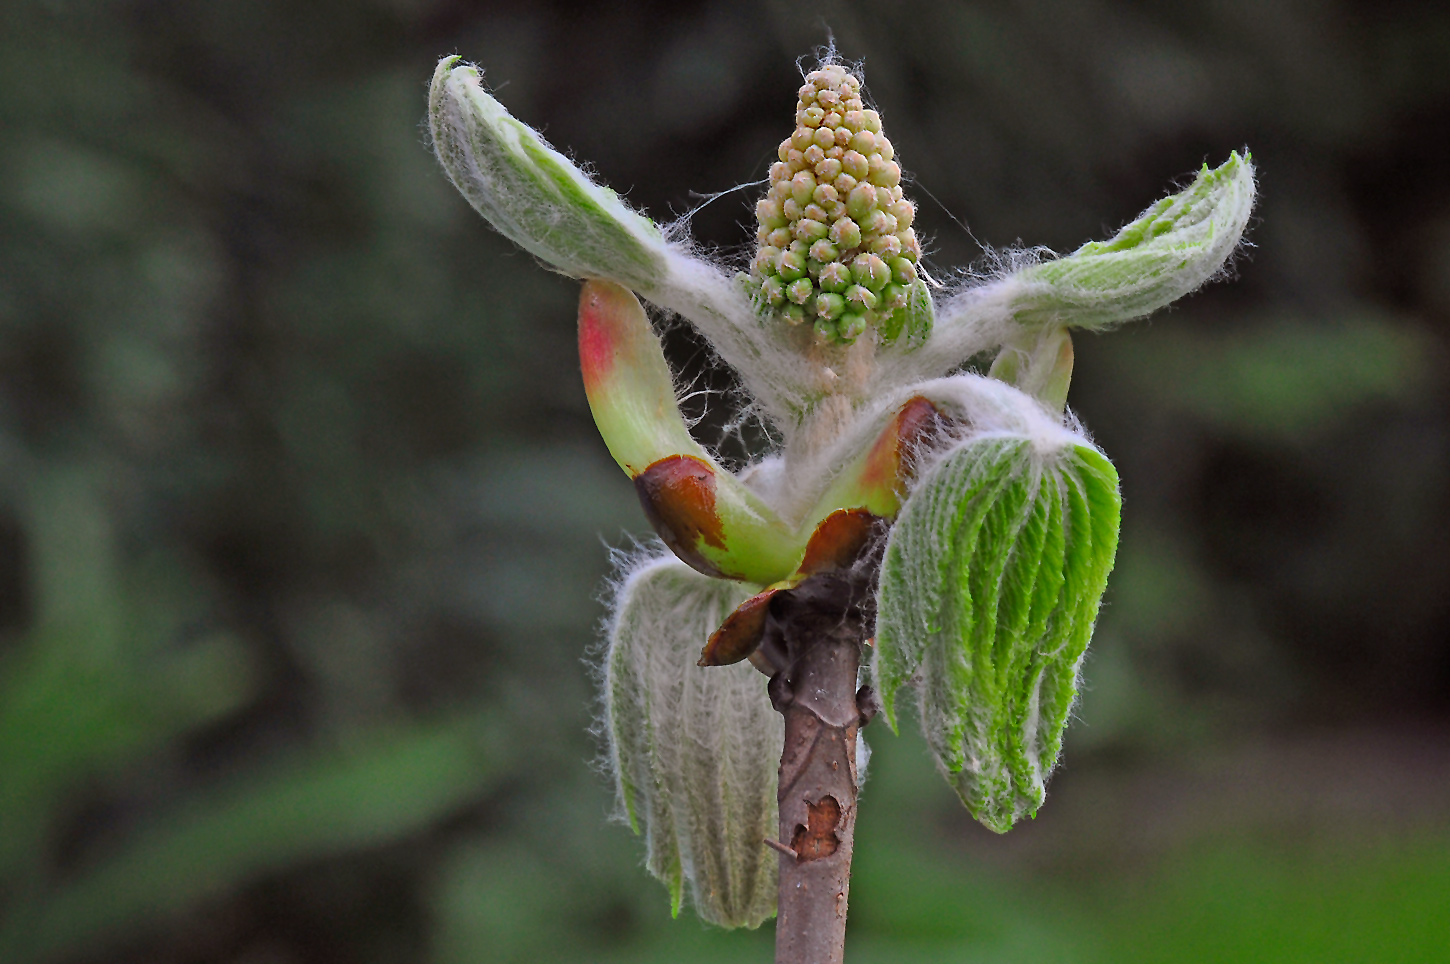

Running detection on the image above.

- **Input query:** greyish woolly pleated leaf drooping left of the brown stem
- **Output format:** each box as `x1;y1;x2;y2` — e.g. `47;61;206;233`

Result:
605;557;784;928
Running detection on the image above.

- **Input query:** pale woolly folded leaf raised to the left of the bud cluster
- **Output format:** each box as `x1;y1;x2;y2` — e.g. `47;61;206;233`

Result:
428;57;666;290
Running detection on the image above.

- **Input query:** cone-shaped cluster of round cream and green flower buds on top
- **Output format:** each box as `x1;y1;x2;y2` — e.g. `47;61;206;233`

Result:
750;64;921;345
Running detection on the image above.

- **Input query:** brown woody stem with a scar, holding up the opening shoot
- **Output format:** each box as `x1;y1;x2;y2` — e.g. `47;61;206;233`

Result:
766;576;870;964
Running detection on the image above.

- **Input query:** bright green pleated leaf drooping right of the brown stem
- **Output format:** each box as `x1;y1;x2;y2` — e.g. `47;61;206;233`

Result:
876;435;1119;834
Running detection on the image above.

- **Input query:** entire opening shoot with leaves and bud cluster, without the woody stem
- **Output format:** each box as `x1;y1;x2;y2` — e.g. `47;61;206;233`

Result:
429;58;1254;910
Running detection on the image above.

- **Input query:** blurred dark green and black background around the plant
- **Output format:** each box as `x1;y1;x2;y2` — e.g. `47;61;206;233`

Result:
0;0;1450;964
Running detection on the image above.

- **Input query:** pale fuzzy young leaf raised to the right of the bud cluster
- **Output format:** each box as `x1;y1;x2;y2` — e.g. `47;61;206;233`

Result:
1012;152;1254;329
